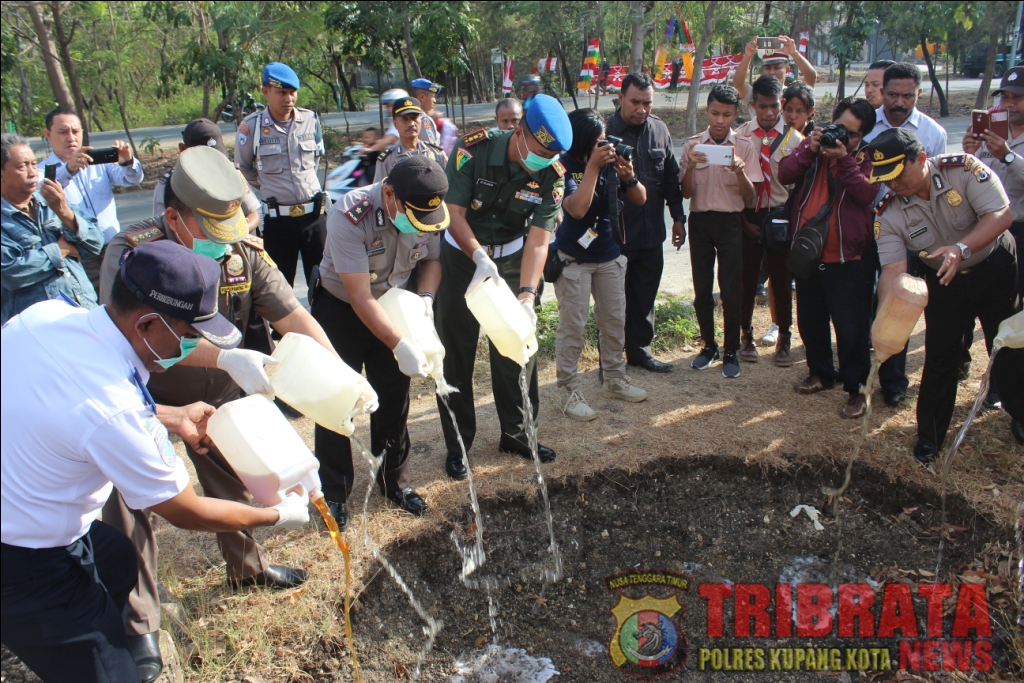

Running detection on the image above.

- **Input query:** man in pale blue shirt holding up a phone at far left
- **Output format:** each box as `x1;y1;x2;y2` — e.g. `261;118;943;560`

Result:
39;109;144;292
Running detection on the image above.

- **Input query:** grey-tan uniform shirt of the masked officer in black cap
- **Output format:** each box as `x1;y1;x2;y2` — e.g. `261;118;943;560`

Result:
319;182;441;302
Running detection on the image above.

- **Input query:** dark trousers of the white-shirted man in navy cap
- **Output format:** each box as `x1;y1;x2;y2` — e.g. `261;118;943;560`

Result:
0;521;139;683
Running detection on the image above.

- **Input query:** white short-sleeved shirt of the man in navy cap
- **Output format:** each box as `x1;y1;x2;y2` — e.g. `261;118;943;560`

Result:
0;300;189;548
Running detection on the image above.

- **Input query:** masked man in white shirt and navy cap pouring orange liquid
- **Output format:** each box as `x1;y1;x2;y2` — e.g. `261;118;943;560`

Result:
0;240;309;683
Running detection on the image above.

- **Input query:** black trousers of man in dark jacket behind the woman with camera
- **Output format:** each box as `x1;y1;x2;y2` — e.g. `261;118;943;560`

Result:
622;245;665;364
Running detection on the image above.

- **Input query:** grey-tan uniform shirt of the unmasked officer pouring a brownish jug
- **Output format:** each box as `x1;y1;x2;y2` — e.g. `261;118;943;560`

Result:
874;154;1010;269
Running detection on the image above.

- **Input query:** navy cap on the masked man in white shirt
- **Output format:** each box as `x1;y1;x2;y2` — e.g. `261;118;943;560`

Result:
121;240;242;348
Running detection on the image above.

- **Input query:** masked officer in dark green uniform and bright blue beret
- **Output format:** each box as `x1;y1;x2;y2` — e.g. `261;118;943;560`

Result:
437;94;572;480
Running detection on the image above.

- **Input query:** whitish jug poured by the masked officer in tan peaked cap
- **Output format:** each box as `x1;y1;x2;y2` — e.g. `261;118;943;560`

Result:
266;332;377;436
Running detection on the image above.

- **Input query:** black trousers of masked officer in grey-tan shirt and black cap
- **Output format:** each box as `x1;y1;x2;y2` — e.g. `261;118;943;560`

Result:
312;289;411;503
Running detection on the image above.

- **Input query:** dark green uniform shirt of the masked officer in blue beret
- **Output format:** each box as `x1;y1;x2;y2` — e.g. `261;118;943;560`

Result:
444;130;565;245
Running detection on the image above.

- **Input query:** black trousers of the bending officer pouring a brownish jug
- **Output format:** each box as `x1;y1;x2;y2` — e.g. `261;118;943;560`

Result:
918;236;1017;447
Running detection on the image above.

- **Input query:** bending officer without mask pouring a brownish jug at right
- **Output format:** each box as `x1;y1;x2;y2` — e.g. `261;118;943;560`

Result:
866;128;1017;463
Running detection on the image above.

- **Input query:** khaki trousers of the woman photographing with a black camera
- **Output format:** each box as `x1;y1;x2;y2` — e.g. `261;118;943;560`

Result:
555;252;626;387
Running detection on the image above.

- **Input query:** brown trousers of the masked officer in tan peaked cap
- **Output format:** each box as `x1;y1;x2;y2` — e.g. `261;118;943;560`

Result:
103;445;268;636
